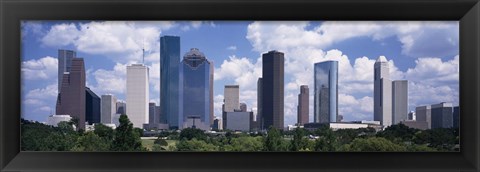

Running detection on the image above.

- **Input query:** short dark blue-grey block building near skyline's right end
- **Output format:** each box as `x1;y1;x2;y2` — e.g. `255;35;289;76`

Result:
432;102;453;128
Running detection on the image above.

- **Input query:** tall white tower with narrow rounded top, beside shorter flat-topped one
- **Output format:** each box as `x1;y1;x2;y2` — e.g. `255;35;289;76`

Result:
373;56;392;127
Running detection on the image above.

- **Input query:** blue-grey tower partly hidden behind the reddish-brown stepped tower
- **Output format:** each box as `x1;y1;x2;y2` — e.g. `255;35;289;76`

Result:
58;50;77;93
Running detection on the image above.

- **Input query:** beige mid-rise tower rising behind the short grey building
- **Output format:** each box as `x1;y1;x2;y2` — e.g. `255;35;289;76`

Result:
222;85;240;128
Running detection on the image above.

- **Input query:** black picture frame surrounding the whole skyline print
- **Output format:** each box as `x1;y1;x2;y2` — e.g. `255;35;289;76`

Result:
0;0;480;172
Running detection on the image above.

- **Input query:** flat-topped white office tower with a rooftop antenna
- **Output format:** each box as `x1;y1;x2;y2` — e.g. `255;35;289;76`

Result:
126;64;149;128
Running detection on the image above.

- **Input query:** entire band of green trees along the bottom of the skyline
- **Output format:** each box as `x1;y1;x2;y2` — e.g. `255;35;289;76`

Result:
21;115;459;152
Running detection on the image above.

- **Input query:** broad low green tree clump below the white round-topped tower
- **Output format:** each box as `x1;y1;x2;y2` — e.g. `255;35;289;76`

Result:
341;137;407;152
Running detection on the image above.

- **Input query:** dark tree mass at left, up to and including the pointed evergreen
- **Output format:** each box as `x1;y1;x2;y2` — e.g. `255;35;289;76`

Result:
21;115;146;151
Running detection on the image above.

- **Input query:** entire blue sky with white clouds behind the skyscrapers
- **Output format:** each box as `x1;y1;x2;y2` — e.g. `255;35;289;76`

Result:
21;21;459;126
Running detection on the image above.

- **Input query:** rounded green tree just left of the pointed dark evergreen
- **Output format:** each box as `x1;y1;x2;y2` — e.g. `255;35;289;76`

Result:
72;132;110;152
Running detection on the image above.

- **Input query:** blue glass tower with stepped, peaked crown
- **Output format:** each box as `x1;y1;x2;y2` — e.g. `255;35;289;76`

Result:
179;48;213;130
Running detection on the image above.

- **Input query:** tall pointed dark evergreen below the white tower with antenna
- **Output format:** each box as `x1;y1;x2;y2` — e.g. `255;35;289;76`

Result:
111;114;145;151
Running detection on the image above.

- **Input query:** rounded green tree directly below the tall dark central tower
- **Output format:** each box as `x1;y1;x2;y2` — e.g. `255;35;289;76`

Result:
263;126;288;151
